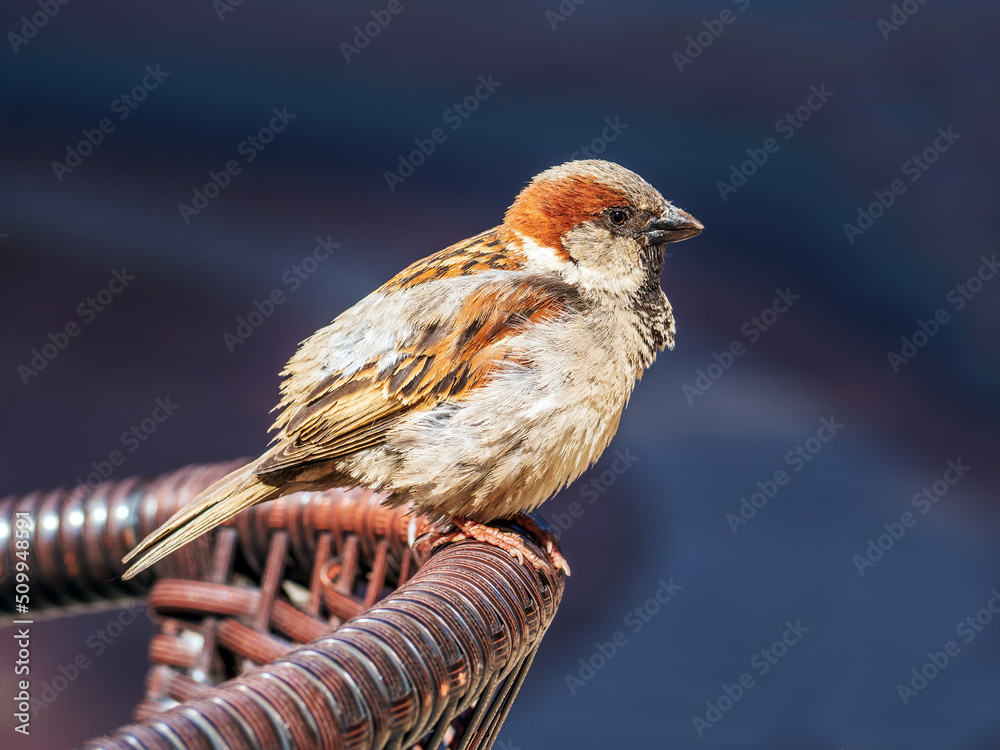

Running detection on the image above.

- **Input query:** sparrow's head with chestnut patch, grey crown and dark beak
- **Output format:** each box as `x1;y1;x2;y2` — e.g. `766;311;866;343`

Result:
504;159;704;293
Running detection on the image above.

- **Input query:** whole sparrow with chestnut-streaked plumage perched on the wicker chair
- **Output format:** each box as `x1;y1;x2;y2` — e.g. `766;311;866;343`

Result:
123;159;704;578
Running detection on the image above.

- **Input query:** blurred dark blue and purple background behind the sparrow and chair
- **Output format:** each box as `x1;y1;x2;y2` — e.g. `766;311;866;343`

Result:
0;0;1000;750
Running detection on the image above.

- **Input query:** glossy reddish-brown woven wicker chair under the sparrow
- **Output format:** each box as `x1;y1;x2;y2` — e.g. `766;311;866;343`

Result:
0;462;563;750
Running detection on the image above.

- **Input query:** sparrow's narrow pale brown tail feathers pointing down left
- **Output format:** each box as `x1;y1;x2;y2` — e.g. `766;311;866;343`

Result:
122;464;283;580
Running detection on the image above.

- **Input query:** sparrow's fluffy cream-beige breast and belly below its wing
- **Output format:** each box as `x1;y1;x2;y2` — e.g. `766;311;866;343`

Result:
352;306;637;520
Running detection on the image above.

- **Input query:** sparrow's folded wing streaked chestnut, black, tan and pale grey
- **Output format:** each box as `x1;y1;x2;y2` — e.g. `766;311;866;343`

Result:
257;234;577;482
